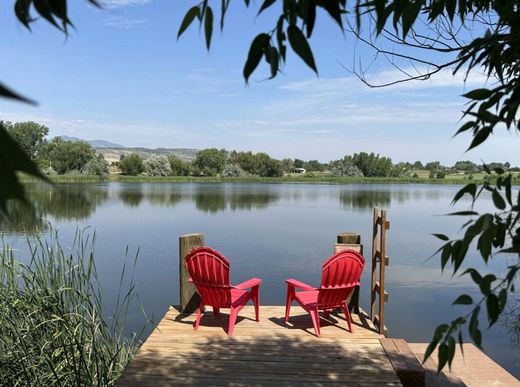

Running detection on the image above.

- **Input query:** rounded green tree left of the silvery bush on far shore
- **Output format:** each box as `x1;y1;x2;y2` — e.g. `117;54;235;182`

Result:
38;137;96;174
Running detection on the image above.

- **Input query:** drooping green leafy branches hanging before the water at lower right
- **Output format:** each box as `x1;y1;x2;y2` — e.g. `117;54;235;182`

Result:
425;169;520;369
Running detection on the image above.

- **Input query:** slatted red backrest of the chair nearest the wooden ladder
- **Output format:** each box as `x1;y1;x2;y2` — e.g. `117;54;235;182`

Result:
318;250;365;309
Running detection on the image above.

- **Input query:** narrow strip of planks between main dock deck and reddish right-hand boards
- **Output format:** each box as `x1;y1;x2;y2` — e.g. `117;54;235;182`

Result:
380;338;425;387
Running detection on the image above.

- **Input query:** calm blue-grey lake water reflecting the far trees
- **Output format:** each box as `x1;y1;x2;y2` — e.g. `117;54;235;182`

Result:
3;183;520;377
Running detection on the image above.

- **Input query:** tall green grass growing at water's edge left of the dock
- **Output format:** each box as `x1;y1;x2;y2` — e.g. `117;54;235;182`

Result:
0;231;145;386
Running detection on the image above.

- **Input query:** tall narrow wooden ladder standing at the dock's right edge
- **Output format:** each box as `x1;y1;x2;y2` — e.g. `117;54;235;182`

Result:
370;208;390;336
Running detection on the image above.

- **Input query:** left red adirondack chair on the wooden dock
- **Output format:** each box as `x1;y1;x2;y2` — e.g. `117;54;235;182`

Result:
185;247;262;336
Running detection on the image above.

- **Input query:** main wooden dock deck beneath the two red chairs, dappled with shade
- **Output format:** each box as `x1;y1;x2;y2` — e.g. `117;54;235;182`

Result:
116;306;401;386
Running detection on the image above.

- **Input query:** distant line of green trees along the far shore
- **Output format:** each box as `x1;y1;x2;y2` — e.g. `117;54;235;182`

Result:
4;121;520;179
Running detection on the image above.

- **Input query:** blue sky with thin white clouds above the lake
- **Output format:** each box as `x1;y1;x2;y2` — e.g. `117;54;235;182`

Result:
0;0;520;165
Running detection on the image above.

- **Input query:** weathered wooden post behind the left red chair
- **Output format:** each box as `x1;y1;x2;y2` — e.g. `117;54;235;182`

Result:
179;234;204;313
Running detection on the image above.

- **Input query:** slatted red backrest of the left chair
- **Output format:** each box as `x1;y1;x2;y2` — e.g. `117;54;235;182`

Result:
184;247;231;308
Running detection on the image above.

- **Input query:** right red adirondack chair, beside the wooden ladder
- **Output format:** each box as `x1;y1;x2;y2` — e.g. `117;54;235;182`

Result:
285;250;365;337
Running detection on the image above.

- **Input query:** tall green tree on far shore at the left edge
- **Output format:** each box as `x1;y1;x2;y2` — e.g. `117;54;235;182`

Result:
2;121;49;160
